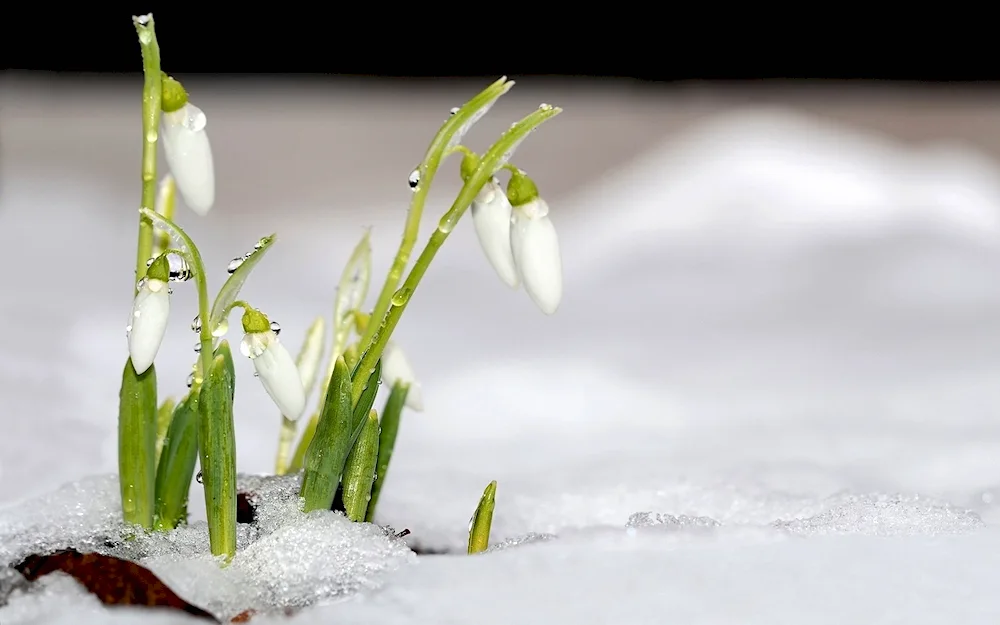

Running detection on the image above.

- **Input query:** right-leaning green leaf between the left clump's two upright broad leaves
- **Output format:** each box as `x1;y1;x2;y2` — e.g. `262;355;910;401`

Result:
156;386;201;531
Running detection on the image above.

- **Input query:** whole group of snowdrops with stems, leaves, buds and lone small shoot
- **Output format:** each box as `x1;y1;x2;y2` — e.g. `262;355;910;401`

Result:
118;15;562;562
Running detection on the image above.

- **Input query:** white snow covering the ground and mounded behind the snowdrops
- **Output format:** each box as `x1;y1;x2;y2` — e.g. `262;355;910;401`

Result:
0;100;1000;625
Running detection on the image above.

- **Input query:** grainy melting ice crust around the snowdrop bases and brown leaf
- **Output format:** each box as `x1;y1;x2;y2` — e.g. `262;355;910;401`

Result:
0;476;416;622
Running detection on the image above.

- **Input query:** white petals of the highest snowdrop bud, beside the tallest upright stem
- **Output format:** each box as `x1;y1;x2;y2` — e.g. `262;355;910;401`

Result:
163;102;215;215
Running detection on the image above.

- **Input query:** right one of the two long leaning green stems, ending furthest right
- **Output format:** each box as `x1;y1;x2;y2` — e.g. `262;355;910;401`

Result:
352;106;562;402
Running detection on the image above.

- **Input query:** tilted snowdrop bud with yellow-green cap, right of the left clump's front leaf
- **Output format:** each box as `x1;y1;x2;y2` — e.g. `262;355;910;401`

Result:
240;308;306;421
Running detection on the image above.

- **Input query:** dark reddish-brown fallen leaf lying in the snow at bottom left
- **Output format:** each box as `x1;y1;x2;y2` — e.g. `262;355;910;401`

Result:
14;549;219;623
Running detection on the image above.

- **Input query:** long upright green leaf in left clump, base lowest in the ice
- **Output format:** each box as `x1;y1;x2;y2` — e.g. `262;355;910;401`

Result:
198;341;236;561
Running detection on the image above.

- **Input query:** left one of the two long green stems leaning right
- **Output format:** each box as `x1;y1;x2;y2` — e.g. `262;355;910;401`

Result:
355;77;514;348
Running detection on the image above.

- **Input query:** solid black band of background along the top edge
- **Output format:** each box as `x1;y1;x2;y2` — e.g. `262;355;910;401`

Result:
0;7;1000;83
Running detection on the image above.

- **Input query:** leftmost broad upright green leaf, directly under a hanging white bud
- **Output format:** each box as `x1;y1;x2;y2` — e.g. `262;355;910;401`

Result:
118;358;156;529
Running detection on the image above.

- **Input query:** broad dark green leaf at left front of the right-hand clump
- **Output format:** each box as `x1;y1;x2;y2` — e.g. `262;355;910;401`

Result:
299;358;354;512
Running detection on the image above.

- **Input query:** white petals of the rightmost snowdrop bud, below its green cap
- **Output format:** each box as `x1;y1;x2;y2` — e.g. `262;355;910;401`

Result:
510;197;562;315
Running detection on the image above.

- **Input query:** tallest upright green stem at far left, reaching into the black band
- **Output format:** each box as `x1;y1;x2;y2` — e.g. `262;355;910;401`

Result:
132;14;163;293
